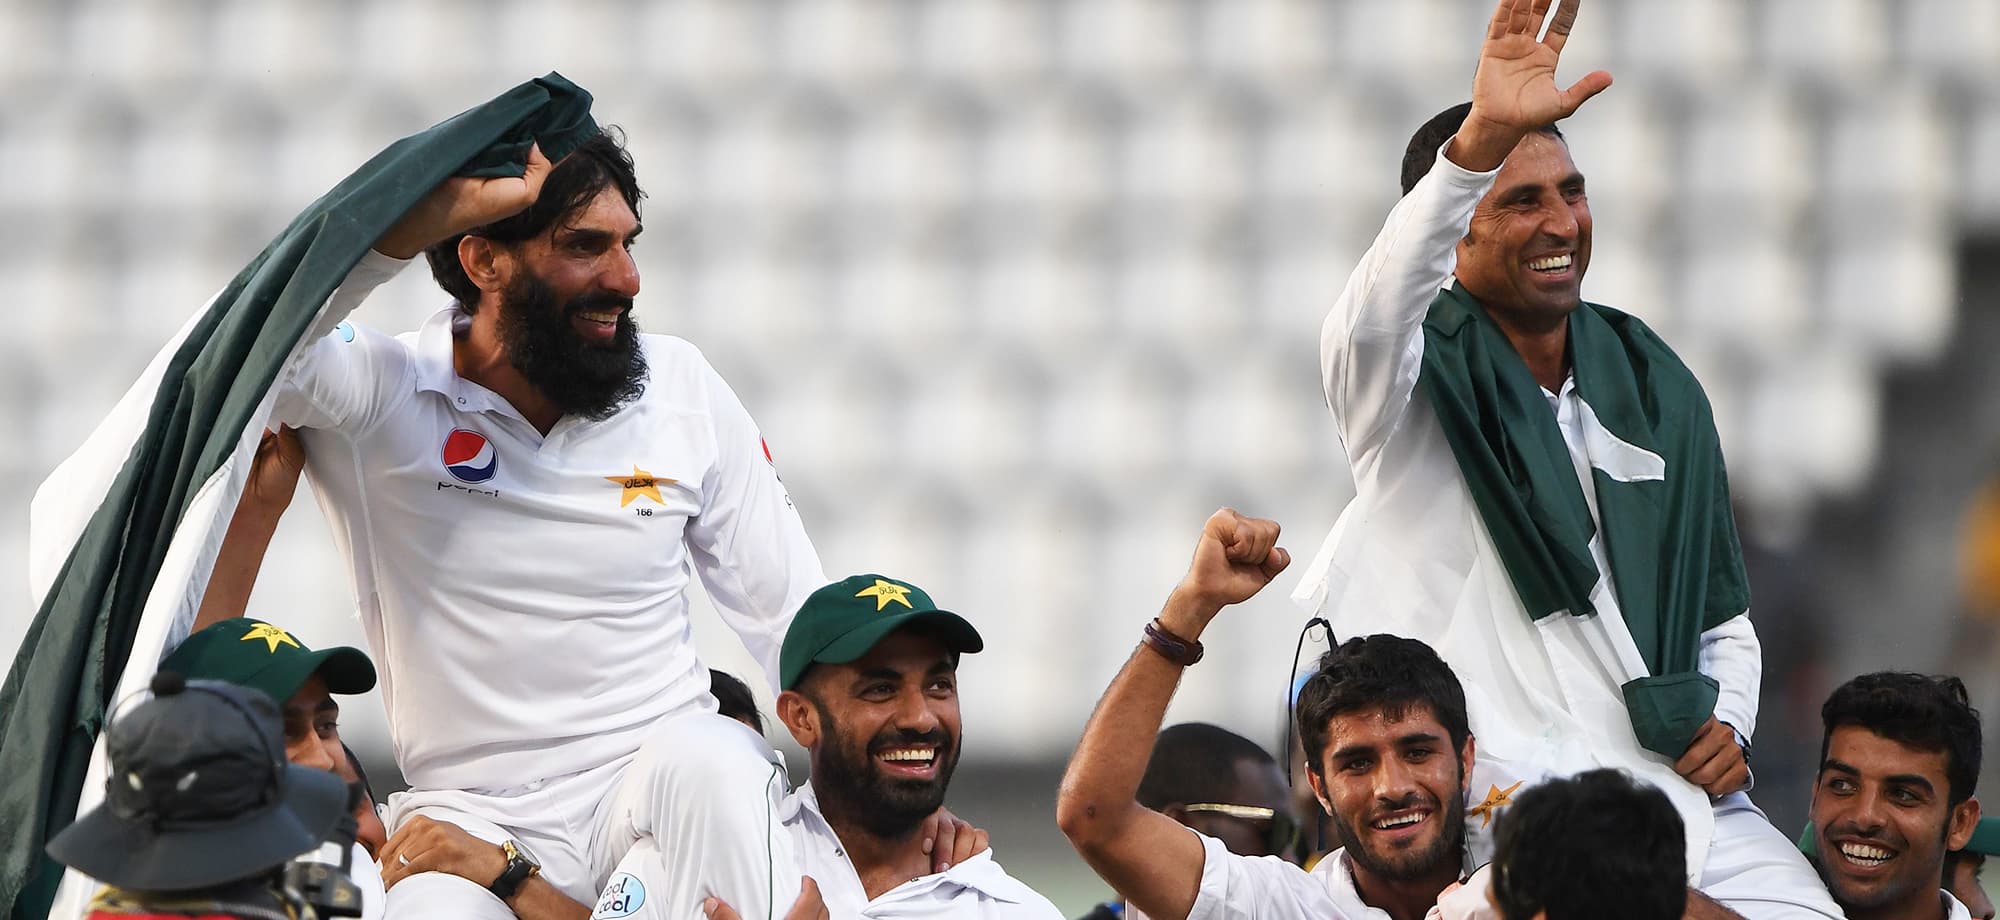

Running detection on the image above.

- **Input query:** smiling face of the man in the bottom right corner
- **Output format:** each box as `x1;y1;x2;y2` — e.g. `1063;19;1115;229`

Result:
1812;726;1980;918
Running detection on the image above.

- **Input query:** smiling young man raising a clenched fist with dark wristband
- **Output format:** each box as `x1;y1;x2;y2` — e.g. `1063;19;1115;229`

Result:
1056;508;1472;920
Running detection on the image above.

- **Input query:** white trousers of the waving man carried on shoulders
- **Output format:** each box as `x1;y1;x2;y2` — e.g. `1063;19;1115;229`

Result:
1700;792;1846;920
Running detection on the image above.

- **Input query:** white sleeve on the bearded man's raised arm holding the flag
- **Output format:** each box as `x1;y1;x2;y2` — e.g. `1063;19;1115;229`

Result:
272;250;408;428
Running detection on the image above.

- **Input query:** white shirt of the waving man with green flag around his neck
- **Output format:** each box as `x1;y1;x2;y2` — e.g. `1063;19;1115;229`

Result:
1294;152;1762;880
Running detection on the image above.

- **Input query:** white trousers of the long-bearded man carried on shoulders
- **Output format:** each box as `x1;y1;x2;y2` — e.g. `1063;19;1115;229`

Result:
386;712;800;920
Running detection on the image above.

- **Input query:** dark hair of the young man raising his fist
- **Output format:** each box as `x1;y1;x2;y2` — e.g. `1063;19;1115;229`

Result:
1294;634;1472;776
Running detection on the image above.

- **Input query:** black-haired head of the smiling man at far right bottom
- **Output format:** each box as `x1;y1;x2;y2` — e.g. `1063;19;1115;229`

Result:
1812;672;1980;920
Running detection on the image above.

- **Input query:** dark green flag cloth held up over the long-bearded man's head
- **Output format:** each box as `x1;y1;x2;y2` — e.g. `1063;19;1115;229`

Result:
0;74;598;920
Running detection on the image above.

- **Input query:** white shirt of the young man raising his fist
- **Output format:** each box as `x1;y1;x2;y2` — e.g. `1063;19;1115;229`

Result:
1188;828;1390;920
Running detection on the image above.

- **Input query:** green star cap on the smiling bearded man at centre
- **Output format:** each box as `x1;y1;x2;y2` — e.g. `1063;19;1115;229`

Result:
778;574;986;690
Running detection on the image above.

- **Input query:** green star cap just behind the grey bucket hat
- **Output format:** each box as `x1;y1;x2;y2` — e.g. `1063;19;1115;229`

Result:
160;616;376;708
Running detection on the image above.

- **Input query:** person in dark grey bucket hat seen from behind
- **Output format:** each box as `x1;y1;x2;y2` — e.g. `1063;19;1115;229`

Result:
48;672;348;920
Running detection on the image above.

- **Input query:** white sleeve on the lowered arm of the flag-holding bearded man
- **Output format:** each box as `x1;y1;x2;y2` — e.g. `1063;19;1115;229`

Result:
686;360;826;692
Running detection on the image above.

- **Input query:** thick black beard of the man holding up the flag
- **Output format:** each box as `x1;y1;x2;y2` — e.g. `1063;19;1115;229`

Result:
500;270;646;422
